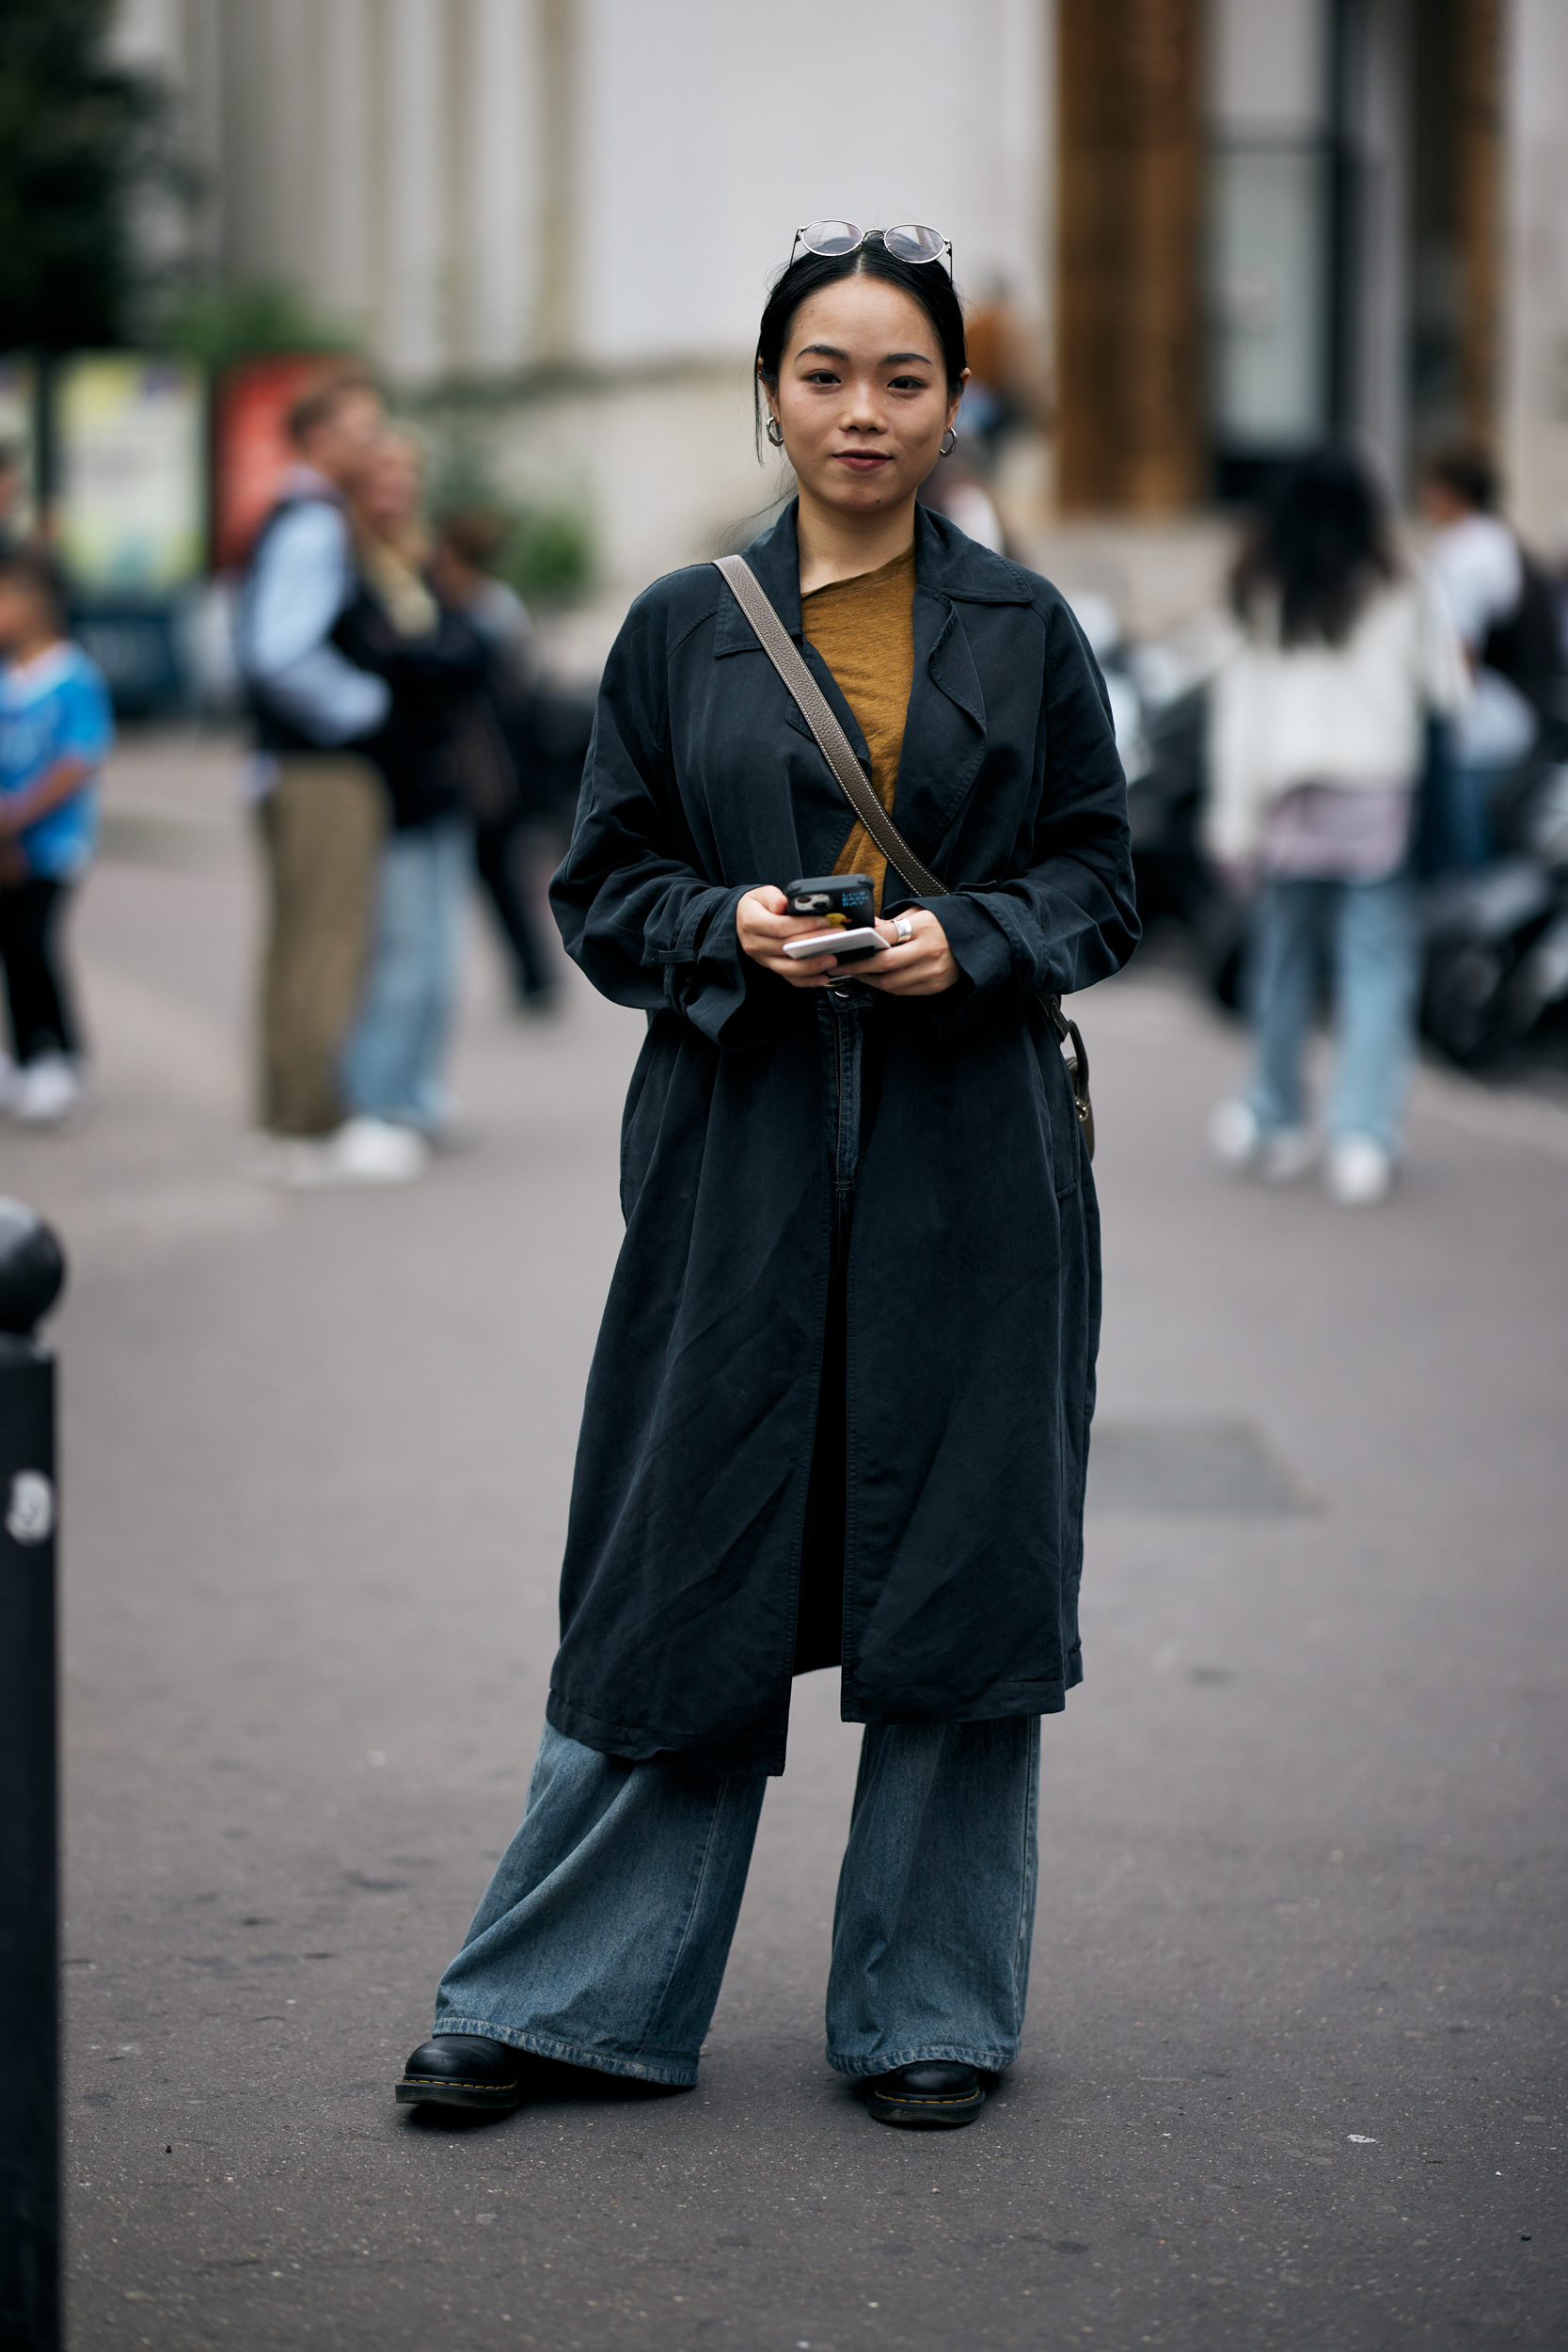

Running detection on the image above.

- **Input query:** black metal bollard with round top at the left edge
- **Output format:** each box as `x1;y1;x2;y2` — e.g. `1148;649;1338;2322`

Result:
0;1200;66;2352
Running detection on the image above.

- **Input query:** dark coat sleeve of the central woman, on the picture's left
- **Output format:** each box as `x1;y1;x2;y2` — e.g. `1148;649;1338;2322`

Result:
550;593;783;1044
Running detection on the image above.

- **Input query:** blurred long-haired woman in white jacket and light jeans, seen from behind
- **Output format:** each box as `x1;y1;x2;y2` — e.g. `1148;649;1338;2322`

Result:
1206;447;1467;1204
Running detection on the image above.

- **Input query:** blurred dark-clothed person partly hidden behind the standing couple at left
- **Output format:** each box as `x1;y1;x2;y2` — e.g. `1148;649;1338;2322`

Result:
430;508;555;1014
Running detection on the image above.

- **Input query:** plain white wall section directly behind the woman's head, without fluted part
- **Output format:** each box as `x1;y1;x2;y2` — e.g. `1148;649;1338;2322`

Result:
578;0;1049;360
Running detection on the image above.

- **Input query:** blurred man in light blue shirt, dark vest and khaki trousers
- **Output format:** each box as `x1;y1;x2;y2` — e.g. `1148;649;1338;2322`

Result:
237;372;425;1184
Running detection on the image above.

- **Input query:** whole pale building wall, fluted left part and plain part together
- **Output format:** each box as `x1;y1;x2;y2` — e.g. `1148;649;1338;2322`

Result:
118;0;1051;384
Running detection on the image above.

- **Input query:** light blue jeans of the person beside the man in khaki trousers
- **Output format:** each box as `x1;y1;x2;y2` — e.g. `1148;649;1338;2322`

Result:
343;817;472;1134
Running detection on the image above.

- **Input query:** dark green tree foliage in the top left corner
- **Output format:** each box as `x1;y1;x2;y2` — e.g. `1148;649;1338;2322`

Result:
0;0;174;351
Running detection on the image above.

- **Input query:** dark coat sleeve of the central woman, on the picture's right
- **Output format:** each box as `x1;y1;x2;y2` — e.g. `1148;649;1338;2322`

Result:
922;602;1140;1033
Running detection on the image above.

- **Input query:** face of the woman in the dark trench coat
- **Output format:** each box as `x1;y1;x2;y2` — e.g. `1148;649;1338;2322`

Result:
767;278;961;516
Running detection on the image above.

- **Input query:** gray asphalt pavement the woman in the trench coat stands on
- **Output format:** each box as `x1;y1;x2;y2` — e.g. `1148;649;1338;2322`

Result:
15;724;1568;2352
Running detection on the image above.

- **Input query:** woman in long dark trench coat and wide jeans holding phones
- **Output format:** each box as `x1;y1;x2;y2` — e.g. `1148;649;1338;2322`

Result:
397;224;1138;2124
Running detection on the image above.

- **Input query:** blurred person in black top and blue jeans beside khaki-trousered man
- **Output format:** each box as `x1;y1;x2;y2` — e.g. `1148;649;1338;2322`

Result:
343;433;484;1152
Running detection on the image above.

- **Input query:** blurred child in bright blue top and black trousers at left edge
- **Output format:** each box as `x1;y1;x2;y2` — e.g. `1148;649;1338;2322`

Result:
0;548;113;1127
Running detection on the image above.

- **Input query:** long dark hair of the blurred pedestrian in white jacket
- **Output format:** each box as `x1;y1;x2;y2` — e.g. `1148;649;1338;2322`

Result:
1232;442;1399;644
